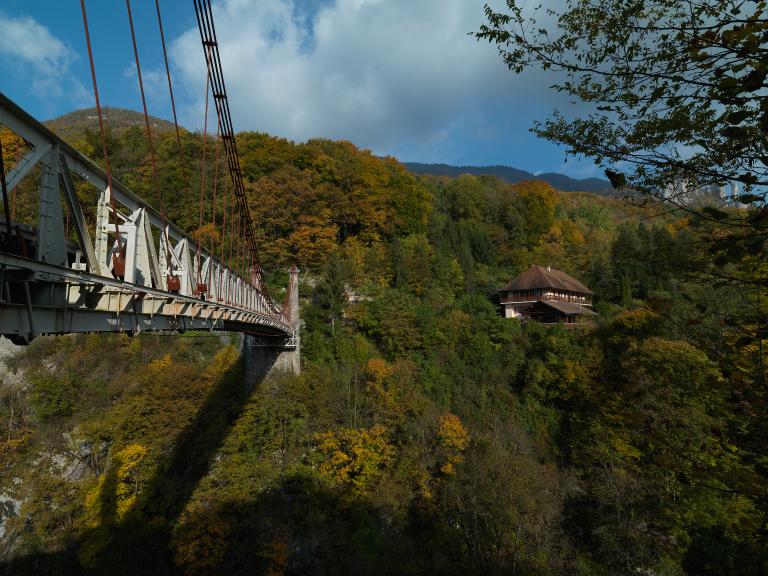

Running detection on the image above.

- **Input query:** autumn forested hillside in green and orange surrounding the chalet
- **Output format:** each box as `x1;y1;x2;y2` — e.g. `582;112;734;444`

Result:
0;119;768;576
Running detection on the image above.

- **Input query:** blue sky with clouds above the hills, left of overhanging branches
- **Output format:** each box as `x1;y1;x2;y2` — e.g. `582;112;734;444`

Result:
0;0;598;177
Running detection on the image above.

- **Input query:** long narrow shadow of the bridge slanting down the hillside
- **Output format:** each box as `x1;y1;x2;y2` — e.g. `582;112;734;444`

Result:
0;344;284;576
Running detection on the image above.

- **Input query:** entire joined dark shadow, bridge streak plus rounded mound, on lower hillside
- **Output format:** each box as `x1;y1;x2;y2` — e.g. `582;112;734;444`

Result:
0;340;520;576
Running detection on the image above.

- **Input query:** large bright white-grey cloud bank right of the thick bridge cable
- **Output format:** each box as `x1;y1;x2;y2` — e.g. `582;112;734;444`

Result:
172;0;530;153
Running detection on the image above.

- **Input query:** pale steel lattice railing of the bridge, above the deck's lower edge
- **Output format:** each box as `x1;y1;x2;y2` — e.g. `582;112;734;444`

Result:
0;93;292;342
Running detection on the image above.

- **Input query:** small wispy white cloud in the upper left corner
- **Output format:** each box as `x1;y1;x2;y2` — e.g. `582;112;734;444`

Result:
0;13;82;97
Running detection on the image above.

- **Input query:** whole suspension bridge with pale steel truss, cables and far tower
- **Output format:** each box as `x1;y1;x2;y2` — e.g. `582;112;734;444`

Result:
0;0;299;370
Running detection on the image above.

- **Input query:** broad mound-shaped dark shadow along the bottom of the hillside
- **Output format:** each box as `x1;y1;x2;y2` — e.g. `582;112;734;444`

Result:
5;474;462;576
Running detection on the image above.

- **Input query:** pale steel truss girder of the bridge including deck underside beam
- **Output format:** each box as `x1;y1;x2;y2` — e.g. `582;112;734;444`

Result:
0;93;294;337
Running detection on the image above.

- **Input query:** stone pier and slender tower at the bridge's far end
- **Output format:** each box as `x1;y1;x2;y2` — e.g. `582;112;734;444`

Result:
242;266;301;385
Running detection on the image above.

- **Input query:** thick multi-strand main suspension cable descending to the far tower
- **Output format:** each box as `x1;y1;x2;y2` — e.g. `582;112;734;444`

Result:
194;0;282;315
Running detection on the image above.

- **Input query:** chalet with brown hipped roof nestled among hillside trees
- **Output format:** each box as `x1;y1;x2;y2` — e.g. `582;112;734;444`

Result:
500;266;597;324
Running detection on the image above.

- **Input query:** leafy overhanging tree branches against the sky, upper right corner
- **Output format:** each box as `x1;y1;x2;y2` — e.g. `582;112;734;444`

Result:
477;0;768;199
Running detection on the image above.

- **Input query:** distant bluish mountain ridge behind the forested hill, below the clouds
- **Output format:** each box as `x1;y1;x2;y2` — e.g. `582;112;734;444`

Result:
403;162;613;195
